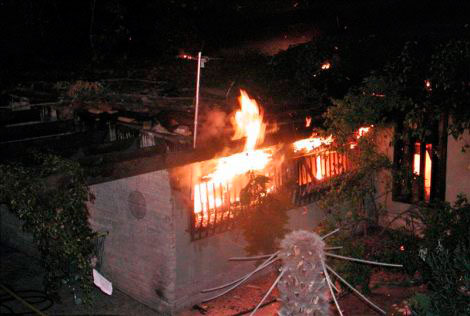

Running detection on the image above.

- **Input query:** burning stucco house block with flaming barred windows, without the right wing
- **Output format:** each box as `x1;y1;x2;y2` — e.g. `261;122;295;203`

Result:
81;91;351;312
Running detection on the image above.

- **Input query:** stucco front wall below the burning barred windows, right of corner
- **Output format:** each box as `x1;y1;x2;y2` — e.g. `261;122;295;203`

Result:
175;184;323;308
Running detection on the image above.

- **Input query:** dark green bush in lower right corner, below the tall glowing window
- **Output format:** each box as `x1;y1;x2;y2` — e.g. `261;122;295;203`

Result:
372;196;470;316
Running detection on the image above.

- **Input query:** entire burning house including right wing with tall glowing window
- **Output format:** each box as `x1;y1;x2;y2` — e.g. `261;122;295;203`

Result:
1;86;470;314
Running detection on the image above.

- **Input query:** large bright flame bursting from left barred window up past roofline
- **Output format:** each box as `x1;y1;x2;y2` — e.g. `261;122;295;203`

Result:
194;90;273;218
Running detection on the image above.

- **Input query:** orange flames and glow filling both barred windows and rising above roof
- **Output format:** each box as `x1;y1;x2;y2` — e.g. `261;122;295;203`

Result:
192;97;371;229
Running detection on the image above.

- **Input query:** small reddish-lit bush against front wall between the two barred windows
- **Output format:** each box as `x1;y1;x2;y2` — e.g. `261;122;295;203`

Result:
240;174;289;255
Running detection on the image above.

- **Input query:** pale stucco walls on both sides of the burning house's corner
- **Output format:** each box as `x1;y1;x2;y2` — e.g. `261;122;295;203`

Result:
89;165;322;313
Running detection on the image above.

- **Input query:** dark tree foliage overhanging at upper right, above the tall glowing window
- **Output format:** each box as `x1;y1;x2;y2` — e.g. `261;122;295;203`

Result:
339;40;470;139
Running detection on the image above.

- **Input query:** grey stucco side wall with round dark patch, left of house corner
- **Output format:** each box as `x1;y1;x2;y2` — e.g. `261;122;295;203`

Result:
89;170;176;313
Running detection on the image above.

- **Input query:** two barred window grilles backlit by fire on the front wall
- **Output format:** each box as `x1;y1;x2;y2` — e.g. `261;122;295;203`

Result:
190;151;352;240
